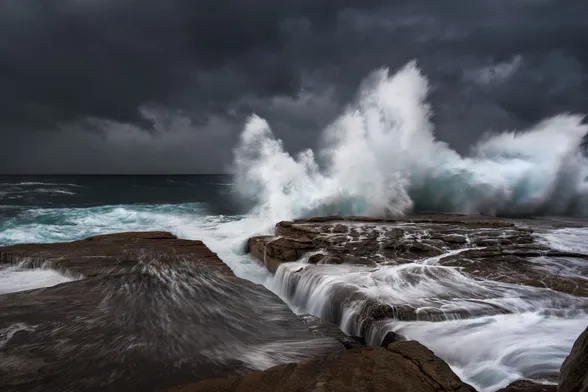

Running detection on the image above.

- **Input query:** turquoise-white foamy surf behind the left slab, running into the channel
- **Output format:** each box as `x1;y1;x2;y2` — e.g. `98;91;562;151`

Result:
0;203;273;283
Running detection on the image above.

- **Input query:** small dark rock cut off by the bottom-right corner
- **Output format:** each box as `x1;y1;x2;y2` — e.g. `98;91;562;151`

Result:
557;328;588;392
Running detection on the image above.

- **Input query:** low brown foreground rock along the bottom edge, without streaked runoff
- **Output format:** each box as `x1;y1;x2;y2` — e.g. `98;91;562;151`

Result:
169;341;475;392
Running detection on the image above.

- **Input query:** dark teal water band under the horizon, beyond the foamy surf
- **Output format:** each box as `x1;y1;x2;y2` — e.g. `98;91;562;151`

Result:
0;175;243;218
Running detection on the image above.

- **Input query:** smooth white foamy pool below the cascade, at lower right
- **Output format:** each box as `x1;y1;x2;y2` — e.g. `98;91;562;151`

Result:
388;313;588;392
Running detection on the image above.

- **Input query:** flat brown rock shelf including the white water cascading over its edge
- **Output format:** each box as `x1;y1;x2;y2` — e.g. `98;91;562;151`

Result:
248;214;588;345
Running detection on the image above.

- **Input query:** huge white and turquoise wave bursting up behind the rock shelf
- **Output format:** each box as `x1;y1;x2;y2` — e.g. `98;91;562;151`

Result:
235;62;588;221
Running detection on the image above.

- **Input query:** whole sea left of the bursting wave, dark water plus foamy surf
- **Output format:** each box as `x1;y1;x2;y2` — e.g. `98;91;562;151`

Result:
0;175;272;282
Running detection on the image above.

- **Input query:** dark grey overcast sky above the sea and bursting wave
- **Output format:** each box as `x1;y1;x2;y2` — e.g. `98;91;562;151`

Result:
0;0;588;173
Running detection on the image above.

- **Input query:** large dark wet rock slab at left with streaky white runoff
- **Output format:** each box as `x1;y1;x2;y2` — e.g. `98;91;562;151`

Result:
0;233;344;392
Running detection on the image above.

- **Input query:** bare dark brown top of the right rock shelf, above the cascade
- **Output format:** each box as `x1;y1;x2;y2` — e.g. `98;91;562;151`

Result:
248;214;588;296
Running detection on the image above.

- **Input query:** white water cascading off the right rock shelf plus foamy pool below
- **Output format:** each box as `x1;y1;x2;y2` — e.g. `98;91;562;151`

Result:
267;233;588;392
